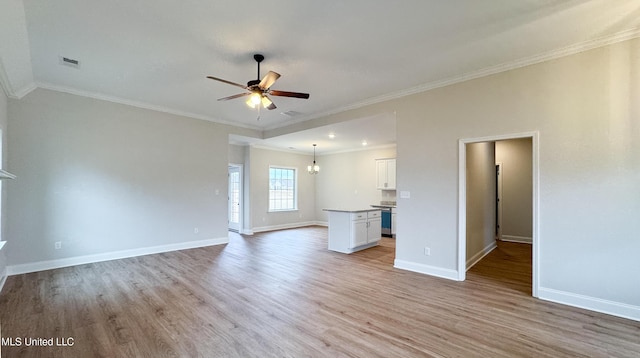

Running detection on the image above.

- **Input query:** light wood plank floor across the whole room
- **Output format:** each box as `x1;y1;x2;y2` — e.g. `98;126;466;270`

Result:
0;227;640;357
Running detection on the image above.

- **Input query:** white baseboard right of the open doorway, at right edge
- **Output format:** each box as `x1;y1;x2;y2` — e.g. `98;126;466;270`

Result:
538;287;640;321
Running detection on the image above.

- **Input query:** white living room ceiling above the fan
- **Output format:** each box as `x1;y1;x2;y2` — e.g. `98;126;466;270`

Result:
0;0;640;150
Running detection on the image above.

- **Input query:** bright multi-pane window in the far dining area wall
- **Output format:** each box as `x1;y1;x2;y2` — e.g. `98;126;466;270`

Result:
269;167;298;211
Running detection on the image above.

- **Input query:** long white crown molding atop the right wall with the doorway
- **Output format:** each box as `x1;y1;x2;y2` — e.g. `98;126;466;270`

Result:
280;28;640;130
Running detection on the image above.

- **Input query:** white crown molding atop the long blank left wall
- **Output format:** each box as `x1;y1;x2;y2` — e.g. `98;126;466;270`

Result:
36;82;262;131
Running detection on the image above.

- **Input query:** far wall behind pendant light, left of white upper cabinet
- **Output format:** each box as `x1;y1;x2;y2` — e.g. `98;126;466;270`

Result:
315;146;396;222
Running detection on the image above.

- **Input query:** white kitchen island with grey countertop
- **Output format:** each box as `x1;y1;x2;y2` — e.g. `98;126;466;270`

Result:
323;208;382;254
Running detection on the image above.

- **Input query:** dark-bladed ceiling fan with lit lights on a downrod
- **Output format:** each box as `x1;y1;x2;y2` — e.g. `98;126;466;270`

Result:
207;54;309;109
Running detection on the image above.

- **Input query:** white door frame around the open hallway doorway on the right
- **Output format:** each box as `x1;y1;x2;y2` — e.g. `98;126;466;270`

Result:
458;131;540;297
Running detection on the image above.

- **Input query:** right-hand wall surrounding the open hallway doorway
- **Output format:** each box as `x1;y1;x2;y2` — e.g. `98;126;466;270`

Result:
268;39;640;320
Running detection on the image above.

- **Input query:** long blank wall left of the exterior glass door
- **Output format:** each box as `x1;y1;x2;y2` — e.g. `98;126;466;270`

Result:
7;90;260;271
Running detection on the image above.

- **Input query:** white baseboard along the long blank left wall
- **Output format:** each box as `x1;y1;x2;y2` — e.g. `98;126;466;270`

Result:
7;237;229;275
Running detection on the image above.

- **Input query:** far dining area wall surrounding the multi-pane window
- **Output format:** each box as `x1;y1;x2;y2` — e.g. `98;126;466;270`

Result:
245;147;316;232
